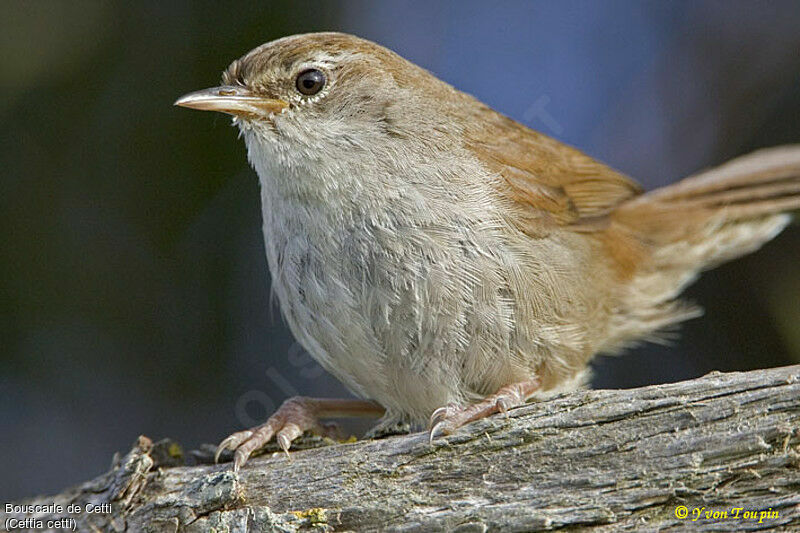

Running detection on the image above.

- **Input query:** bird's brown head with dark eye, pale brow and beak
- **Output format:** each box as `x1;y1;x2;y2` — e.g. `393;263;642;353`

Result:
175;33;460;162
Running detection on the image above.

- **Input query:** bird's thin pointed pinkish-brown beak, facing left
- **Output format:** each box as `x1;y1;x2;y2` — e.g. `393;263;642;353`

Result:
175;85;289;117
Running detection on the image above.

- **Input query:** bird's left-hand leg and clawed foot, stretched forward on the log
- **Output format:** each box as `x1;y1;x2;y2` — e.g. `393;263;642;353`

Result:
214;396;384;471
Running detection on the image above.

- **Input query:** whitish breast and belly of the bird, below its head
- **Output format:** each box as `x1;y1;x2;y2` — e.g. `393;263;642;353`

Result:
238;119;592;420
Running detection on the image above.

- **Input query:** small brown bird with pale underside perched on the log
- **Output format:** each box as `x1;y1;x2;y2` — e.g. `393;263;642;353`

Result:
175;32;800;471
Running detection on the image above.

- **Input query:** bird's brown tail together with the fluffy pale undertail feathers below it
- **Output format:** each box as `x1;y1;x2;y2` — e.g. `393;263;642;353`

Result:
611;145;800;345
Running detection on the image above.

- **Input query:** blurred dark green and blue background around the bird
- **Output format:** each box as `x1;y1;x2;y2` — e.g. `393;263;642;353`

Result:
0;0;800;501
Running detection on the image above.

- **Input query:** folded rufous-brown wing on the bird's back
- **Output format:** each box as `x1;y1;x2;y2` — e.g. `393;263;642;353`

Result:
465;105;642;224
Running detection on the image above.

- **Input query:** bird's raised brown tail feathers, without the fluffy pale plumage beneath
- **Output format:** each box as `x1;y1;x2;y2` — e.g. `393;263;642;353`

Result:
613;145;800;270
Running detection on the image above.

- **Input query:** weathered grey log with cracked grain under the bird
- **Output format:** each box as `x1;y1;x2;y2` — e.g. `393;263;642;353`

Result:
2;366;800;532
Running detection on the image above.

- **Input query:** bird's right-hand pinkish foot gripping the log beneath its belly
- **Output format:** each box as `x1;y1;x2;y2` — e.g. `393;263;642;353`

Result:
428;378;540;442
